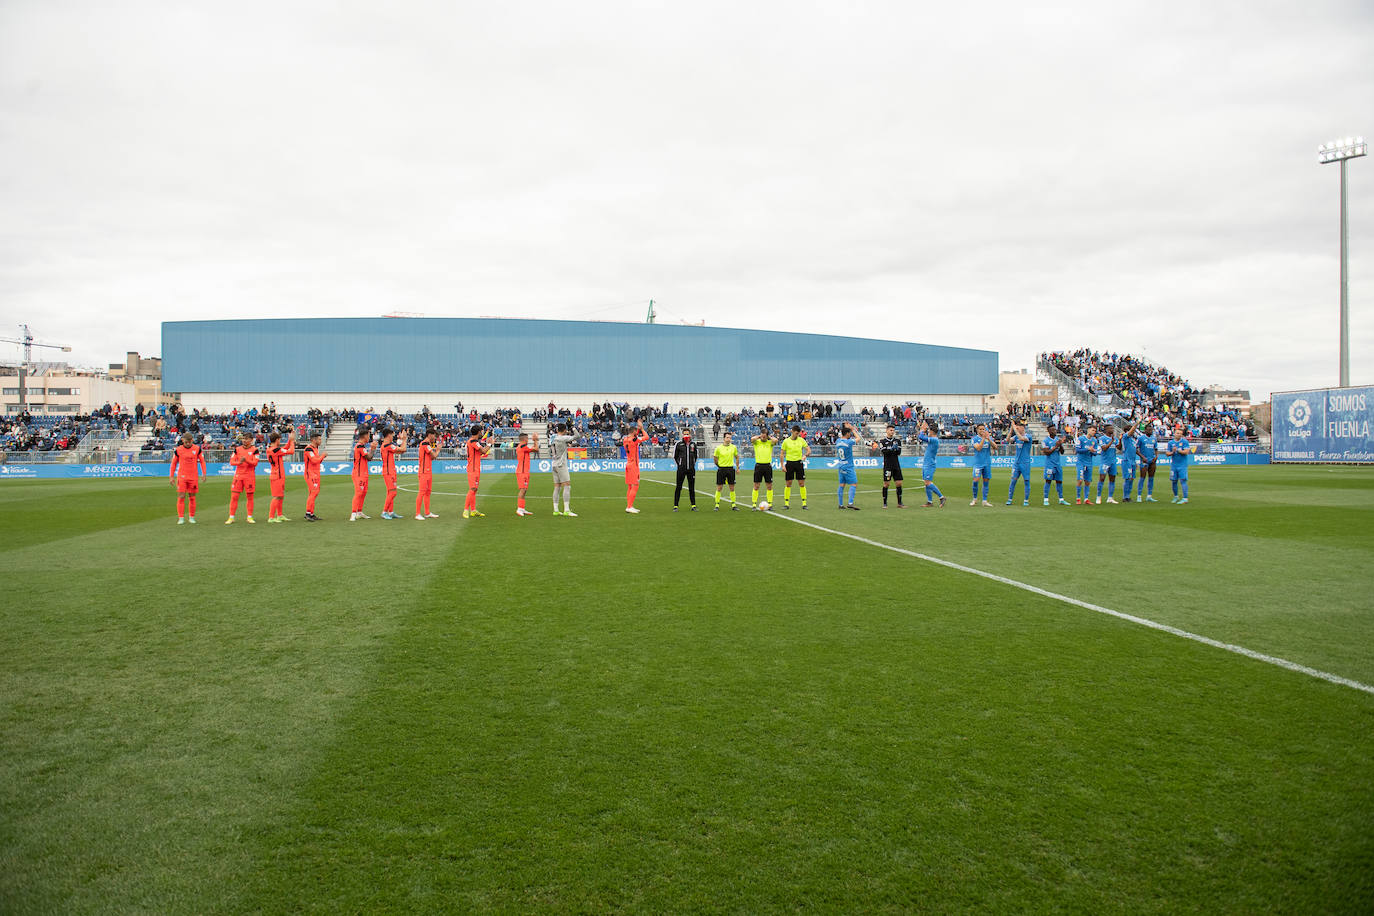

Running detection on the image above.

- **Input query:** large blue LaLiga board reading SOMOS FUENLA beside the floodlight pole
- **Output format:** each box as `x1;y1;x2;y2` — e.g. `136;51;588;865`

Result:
1274;387;1374;464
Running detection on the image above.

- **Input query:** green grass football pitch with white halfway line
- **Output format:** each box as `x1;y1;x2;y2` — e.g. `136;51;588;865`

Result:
0;467;1374;913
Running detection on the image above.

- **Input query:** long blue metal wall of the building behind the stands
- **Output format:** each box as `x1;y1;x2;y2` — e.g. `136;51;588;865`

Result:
162;319;998;394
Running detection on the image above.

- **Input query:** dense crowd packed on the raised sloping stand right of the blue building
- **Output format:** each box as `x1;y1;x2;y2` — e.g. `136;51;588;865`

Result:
1043;349;1253;439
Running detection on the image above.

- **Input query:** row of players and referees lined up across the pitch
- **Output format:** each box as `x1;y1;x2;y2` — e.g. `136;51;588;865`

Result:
160;414;1195;525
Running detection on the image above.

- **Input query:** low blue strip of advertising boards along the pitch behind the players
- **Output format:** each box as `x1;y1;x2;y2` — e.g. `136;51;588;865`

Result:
0;453;1264;481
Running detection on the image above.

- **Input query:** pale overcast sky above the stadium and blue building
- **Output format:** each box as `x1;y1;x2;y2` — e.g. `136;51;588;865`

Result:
0;0;1374;400
